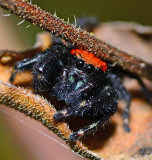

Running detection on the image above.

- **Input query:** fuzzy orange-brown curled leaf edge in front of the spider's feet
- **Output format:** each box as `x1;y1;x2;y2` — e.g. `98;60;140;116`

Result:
0;81;103;160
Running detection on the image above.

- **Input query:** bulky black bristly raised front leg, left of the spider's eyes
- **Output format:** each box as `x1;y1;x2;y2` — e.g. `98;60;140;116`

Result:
32;43;70;96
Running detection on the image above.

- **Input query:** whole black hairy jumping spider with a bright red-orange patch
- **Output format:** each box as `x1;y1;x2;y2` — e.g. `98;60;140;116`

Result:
7;16;151;141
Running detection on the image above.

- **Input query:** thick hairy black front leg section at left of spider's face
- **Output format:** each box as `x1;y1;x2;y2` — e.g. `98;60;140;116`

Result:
32;48;64;95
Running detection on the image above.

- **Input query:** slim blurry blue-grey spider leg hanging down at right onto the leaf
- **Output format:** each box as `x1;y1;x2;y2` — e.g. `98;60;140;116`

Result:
109;73;131;132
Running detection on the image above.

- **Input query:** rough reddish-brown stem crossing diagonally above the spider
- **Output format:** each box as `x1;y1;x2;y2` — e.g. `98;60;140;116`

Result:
0;0;152;80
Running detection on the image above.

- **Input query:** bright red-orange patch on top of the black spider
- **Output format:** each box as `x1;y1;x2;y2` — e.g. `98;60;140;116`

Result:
71;49;107;72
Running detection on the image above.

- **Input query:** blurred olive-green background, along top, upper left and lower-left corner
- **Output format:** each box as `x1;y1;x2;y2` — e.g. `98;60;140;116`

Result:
0;0;152;160
